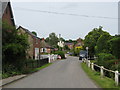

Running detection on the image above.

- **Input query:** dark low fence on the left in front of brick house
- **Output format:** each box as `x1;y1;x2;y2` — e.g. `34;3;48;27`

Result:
25;58;49;68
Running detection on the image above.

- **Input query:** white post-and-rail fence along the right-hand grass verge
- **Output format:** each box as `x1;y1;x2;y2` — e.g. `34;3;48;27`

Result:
82;59;120;86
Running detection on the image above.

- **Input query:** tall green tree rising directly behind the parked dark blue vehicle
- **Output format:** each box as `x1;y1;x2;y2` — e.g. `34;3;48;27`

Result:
84;26;106;56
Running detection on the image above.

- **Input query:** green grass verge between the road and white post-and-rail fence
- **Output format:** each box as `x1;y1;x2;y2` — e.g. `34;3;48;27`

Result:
81;63;120;90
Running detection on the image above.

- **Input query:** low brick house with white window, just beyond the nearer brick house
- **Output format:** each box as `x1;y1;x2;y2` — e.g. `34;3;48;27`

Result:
40;38;53;54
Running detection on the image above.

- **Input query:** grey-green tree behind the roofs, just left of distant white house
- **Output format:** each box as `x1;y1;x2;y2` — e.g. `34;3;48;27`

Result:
45;33;59;47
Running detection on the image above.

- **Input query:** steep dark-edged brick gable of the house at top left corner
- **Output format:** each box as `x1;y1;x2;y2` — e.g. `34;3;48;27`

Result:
0;2;15;26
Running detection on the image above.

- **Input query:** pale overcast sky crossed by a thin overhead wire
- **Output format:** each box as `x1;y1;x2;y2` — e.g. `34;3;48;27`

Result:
11;0;118;40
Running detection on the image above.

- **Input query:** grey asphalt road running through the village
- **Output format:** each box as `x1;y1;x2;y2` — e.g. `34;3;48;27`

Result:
3;56;97;88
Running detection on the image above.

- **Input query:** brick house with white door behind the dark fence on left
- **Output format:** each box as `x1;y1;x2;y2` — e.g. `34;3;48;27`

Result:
17;26;40;60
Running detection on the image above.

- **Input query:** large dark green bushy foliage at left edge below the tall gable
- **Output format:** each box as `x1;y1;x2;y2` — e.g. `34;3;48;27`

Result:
2;22;29;71
